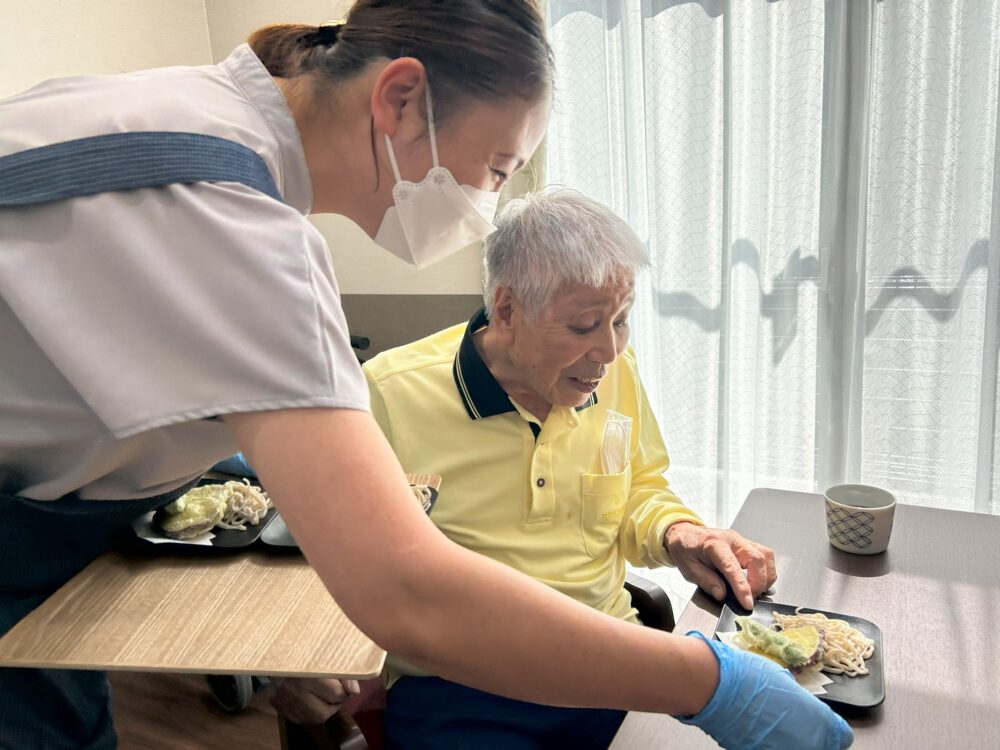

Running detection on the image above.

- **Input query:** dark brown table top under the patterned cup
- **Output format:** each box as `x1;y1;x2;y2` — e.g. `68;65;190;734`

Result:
611;490;1000;750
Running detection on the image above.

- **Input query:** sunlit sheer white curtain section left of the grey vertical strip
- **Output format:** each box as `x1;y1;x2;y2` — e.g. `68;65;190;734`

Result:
548;2;823;524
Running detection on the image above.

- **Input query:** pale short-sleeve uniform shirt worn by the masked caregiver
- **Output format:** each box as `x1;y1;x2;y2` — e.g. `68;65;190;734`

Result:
0;45;368;500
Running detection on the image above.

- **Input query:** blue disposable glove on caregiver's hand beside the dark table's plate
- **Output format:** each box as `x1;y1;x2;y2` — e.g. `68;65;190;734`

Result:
680;631;854;750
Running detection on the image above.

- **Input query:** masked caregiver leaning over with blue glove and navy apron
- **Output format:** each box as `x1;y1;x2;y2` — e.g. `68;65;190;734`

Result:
0;0;849;750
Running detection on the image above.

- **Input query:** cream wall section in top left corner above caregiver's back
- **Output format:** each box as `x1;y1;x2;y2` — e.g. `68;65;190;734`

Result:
0;0;212;98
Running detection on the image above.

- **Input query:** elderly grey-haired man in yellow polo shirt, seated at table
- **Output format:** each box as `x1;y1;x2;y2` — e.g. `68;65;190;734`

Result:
277;190;775;748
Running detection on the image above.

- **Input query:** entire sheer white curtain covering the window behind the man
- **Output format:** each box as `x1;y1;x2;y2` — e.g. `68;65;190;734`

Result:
545;0;1000;526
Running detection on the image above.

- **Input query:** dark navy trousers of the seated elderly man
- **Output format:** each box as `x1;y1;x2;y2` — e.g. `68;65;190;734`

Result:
383;677;625;750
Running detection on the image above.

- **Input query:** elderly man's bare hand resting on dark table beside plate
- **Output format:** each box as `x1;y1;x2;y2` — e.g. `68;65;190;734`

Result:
663;521;778;609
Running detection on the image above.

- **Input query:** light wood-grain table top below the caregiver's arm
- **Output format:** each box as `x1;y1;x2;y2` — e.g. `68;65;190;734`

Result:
0;550;385;679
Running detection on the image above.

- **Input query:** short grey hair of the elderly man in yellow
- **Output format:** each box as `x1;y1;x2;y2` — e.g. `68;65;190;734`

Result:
483;188;649;321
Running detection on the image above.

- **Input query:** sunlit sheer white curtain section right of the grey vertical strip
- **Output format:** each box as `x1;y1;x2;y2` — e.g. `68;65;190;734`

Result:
857;2;1000;510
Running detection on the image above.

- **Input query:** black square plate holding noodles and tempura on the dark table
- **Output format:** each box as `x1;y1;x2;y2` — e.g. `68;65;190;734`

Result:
715;601;885;709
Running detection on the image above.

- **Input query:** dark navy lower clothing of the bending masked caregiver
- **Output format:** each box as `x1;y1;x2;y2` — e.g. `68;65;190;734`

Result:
0;485;191;750
